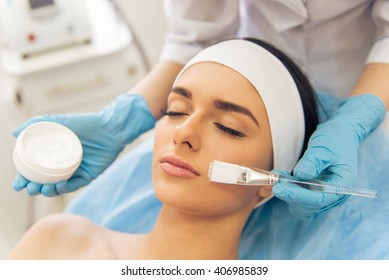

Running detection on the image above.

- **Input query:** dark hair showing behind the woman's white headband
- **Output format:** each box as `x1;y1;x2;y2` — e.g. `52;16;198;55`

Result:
242;38;318;157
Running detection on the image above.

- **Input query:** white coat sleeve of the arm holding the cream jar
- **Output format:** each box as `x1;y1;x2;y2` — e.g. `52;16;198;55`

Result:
160;0;239;64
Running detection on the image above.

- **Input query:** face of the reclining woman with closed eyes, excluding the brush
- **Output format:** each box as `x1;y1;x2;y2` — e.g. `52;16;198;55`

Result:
153;62;272;215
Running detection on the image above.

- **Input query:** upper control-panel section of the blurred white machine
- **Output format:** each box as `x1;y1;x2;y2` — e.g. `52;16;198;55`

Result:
3;0;92;59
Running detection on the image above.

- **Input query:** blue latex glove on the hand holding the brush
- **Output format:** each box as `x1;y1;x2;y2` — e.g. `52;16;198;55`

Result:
273;94;386;221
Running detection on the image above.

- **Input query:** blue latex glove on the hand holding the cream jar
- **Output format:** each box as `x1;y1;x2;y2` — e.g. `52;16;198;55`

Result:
13;94;155;197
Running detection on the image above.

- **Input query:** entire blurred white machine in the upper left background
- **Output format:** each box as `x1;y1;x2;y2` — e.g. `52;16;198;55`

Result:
0;0;147;118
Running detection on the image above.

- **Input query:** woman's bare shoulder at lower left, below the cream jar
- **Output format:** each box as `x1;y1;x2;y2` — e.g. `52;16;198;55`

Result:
7;214;109;259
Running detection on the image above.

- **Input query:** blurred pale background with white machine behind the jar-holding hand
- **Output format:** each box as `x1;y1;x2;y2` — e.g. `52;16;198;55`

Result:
0;0;166;258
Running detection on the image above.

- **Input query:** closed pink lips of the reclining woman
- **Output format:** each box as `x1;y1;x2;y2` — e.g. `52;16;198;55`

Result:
160;156;200;178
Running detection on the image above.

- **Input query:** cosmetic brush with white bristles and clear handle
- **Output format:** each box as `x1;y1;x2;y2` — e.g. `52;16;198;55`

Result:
208;160;377;198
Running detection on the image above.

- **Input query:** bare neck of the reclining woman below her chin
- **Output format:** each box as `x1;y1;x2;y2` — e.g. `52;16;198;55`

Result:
136;205;249;259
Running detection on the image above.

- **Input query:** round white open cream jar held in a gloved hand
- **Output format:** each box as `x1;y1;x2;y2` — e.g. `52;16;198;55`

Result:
13;122;82;184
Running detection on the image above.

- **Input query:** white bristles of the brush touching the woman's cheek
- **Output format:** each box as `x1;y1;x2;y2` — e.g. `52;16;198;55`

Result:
208;160;241;184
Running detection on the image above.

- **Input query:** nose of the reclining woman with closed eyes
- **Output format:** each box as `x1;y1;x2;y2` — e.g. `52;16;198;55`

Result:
173;116;201;151
